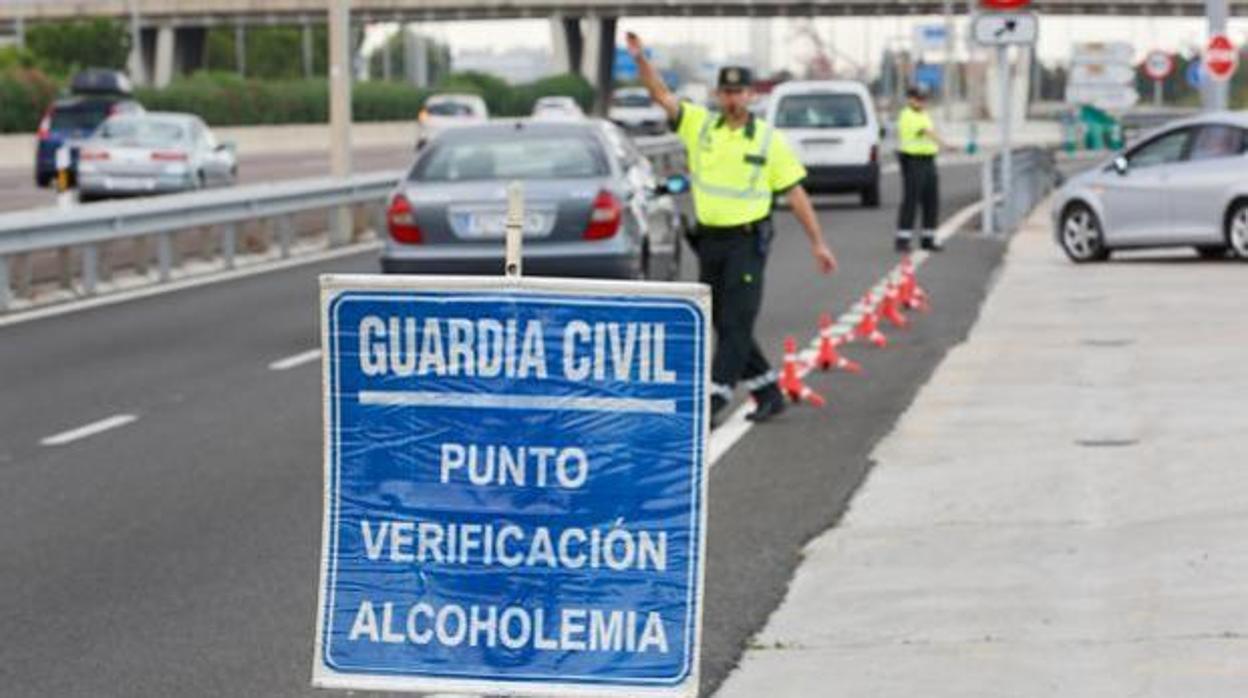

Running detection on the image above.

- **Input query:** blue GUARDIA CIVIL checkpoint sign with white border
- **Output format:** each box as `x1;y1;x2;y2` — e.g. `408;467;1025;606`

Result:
313;276;709;697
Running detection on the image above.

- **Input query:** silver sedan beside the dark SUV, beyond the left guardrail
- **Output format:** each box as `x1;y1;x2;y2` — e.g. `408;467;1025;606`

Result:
77;112;238;201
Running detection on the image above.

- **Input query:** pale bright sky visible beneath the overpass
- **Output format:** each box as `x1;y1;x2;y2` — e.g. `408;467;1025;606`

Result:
374;16;1248;76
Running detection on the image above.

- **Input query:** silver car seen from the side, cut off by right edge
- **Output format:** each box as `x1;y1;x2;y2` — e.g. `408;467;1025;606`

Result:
1052;112;1248;262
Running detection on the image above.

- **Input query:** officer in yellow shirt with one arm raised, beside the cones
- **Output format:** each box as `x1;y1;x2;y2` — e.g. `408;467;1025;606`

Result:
628;32;836;422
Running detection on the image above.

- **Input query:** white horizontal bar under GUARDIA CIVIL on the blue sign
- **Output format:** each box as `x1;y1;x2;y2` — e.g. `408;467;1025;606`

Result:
359;391;676;415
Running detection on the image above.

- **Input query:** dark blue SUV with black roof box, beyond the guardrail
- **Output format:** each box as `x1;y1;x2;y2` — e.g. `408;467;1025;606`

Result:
35;70;144;186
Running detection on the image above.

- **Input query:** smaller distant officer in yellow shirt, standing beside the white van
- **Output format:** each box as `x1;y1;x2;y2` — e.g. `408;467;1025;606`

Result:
894;87;945;252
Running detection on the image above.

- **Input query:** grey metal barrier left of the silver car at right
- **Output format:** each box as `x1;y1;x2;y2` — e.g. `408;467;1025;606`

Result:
981;147;1058;235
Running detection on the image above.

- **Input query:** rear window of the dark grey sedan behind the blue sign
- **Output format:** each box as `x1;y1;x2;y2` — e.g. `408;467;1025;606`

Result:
412;132;608;182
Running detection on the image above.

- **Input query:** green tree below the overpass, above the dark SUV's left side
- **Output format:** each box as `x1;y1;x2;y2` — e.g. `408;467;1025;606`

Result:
26;19;130;75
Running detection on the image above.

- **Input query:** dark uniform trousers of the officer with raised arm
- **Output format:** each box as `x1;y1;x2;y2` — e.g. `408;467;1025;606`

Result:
698;220;776;397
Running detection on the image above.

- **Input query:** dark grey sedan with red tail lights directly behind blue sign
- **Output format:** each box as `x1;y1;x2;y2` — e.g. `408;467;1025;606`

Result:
381;120;685;280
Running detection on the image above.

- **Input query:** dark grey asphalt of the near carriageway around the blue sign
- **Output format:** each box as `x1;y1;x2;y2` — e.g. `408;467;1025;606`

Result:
0;159;1003;698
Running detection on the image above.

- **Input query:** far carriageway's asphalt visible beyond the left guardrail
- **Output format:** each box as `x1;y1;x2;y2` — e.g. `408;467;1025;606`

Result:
0;146;413;211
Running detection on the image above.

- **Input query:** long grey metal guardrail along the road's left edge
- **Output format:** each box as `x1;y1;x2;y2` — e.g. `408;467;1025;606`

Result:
0;136;684;312
